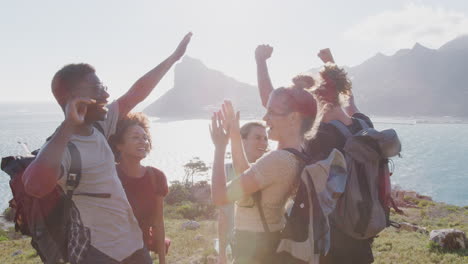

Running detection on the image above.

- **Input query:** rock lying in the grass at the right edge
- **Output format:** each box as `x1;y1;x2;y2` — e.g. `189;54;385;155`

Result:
430;229;467;250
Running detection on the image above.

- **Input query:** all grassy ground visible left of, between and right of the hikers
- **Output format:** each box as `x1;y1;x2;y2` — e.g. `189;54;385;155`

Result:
0;201;468;264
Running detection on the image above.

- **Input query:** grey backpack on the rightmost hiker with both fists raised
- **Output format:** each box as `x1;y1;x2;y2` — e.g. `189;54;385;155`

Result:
330;119;401;239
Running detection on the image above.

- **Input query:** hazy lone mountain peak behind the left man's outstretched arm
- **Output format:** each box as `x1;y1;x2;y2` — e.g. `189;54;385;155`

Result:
144;56;264;118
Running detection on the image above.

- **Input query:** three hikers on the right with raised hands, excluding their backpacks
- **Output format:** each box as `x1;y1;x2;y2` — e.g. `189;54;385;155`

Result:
211;45;373;264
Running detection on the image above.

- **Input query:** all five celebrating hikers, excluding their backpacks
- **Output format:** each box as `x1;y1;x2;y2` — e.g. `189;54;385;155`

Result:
22;33;373;264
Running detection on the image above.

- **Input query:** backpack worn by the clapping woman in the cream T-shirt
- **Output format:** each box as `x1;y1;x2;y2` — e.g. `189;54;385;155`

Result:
252;148;347;264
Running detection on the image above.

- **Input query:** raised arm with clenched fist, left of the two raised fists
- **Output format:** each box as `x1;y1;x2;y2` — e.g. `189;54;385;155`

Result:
255;45;273;107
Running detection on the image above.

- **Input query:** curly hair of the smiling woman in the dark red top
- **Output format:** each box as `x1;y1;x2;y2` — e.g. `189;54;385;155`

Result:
109;112;153;161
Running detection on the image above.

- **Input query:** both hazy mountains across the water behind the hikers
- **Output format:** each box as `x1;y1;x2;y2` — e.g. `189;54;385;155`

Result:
145;35;468;118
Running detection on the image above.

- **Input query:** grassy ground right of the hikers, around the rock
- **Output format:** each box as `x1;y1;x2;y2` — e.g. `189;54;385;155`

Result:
372;201;468;264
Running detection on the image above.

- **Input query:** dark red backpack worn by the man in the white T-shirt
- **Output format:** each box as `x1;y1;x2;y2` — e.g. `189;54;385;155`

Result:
1;123;107;264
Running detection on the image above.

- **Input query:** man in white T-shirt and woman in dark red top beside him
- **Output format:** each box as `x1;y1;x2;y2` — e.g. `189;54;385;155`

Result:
22;33;192;264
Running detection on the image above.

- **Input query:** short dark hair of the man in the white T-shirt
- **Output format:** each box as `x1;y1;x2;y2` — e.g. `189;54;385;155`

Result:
51;63;96;108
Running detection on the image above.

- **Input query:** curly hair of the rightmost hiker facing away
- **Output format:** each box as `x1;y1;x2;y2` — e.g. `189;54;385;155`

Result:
313;63;352;105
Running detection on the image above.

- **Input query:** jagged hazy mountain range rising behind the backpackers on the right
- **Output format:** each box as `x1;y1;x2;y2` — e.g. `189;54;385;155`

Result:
348;35;468;117
